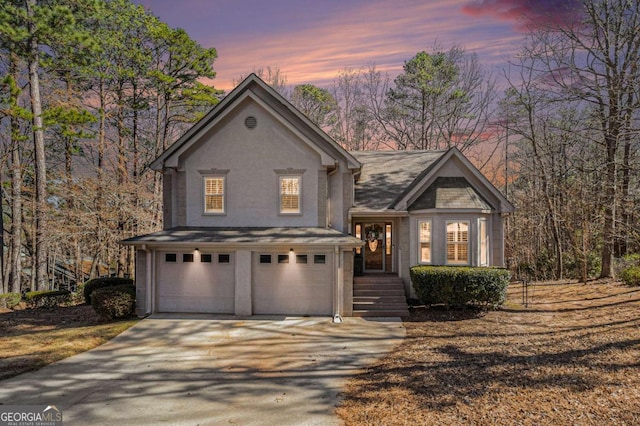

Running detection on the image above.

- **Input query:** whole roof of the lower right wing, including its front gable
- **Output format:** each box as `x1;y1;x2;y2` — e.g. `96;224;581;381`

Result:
352;147;515;213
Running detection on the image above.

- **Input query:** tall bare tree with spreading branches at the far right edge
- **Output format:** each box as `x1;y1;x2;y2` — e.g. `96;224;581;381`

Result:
527;0;640;277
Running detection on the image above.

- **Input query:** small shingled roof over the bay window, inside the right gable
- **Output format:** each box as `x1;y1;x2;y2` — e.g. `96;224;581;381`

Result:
409;177;491;210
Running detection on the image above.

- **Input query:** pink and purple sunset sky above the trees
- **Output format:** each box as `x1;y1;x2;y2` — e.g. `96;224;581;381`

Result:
135;0;576;90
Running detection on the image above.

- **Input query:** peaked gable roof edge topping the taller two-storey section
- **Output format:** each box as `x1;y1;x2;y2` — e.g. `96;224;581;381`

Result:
150;74;361;171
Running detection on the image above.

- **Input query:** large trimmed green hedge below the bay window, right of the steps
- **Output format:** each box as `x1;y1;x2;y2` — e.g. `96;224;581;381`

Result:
411;266;511;308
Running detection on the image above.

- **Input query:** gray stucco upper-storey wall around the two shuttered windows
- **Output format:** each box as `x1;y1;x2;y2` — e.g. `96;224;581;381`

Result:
181;99;323;226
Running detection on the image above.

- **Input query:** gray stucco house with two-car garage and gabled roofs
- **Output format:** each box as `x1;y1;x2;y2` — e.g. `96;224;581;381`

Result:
123;74;514;319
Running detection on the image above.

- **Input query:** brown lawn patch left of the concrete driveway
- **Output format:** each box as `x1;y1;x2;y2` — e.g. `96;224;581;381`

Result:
0;305;138;380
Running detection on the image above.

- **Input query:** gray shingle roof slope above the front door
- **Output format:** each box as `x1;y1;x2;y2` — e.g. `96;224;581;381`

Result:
350;151;445;211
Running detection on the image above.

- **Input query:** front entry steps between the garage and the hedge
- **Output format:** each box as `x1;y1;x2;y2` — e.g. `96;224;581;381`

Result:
353;274;409;317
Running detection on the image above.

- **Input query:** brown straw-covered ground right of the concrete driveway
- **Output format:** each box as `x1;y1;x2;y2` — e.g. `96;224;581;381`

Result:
337;281;640;425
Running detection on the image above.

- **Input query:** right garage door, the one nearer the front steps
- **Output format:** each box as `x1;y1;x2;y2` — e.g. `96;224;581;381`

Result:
252;252;333;315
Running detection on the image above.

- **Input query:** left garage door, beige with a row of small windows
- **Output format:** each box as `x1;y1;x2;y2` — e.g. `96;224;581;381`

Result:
157;251;235;314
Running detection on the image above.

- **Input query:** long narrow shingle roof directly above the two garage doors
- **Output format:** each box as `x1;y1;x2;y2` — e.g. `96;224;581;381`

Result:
122;227;362;245
